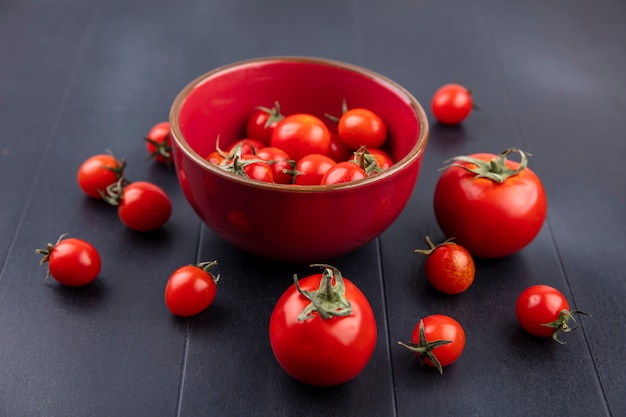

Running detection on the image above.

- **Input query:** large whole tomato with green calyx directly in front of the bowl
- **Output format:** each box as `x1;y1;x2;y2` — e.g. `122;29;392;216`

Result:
269;265;377;386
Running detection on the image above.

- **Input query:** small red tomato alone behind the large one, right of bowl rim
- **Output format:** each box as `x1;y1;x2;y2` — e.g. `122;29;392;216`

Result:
431;83;474;125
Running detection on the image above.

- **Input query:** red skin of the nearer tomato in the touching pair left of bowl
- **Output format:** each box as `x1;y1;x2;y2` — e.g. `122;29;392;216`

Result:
117;181;172;232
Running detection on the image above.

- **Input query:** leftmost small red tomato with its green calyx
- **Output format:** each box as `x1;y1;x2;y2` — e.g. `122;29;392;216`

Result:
36;234;102;287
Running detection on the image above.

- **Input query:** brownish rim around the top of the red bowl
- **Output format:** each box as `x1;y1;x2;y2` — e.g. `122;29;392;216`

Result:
169;55;429;193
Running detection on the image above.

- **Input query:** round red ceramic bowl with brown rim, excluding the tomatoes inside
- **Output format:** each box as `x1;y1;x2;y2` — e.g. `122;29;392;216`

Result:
170;57;428;263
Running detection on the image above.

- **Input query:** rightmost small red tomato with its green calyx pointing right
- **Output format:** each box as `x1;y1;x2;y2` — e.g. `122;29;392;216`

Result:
515;285;589;344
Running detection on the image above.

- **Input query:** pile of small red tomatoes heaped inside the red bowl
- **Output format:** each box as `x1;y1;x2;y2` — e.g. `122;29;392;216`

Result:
205;101;394;185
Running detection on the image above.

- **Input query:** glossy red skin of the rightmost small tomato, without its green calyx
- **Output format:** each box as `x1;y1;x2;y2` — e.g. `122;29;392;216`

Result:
515;285;569;337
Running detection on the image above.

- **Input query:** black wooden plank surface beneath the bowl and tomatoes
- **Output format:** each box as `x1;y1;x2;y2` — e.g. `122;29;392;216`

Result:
0;0;626;417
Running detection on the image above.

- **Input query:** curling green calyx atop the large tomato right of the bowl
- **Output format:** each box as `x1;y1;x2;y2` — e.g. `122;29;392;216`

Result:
442;148;530;183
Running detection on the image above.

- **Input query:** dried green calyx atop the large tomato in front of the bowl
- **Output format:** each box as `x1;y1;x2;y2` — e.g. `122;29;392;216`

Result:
293;264;352;321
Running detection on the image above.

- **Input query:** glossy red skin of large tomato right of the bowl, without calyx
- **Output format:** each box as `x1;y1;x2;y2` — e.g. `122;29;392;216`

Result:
434;153;547;258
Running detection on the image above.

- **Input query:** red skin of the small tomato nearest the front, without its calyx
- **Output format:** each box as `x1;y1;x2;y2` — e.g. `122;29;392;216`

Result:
411;314;466;366
